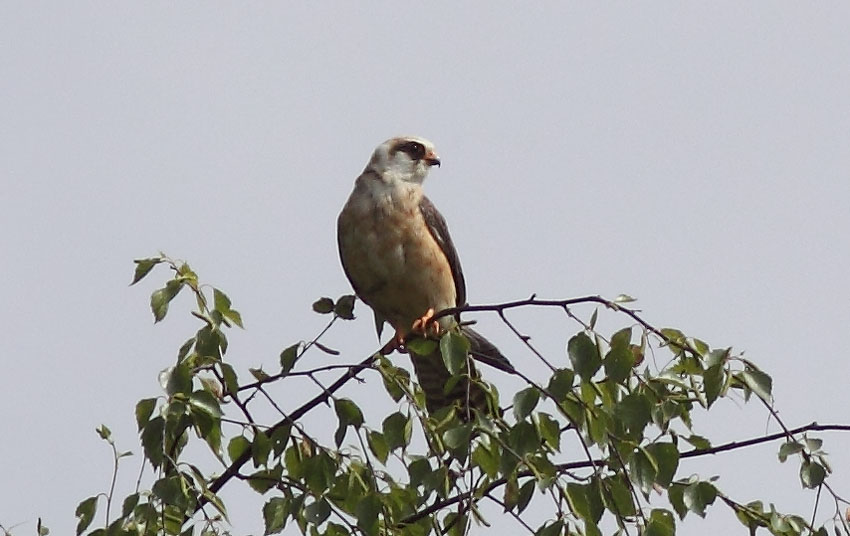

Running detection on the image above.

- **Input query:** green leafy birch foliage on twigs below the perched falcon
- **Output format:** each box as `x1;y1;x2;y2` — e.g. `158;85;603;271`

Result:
39;256;850;536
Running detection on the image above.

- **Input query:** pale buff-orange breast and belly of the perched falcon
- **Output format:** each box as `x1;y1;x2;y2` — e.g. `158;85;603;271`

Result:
338;178;457;333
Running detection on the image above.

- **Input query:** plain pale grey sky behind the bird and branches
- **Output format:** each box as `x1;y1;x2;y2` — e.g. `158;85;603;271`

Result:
0;1;850;534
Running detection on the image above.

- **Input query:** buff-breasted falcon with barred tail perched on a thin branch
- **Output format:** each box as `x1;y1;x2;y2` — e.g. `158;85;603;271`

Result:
337;136;514;412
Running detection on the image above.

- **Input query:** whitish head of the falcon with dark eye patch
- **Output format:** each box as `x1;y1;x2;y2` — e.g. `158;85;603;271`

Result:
367;136;440;184
